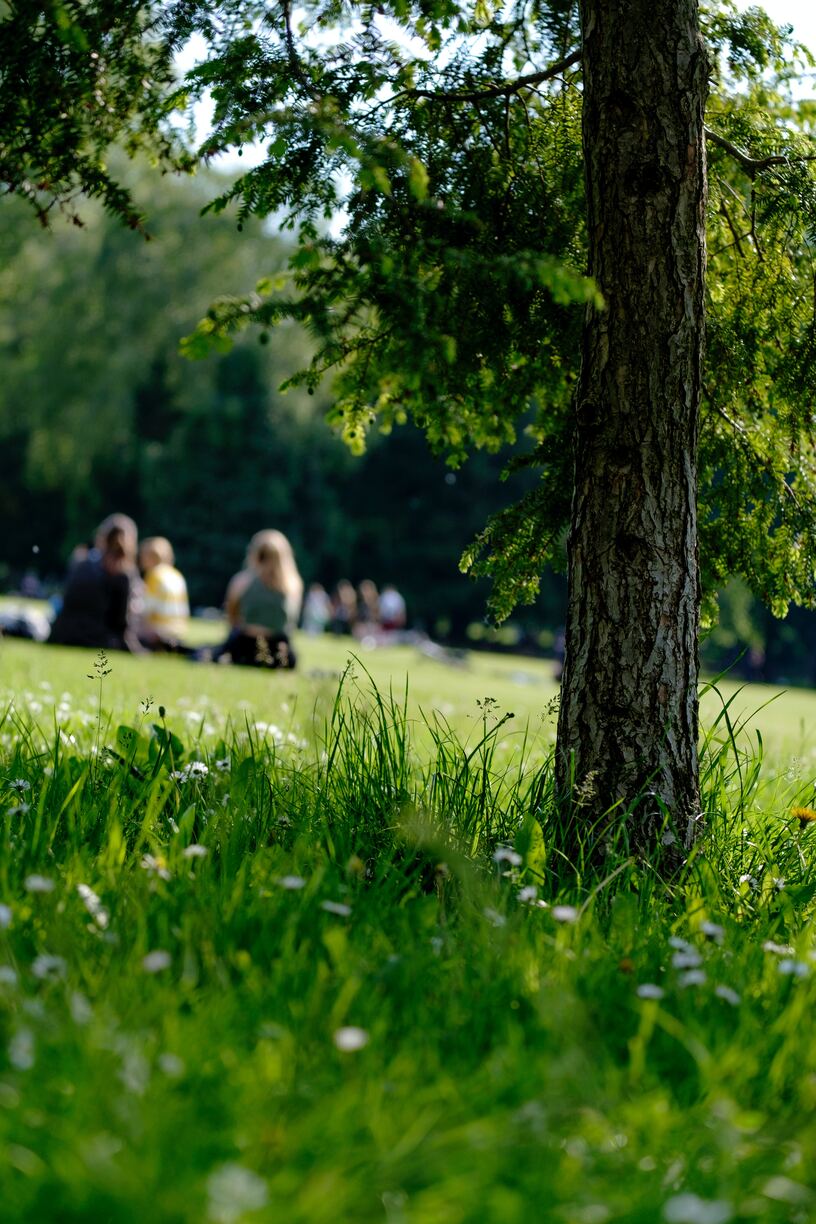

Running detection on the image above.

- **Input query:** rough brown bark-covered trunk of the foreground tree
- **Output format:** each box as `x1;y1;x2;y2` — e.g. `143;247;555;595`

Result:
558;0;708;852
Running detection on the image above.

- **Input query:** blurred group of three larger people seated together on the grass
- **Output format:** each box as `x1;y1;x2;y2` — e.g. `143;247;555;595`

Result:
49;514;303;667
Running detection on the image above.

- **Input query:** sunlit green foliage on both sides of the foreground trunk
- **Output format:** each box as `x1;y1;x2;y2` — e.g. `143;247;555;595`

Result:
4;0;816;617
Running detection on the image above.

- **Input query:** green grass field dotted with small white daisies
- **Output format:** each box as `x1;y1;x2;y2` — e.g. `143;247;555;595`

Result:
0;639;816;1224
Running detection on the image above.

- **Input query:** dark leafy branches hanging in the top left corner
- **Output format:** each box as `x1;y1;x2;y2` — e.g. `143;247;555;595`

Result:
0;0;190;229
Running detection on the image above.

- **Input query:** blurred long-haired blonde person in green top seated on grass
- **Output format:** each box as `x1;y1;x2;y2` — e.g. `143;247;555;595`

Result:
214;530;303;667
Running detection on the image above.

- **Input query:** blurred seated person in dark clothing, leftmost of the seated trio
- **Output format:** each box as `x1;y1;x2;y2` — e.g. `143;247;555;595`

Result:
48;514;141;650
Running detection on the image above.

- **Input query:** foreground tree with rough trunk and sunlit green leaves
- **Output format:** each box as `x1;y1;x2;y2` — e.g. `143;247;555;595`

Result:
1;0;814;861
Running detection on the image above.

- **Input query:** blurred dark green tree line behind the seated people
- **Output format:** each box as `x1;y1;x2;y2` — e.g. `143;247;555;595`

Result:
0;180;563;640
